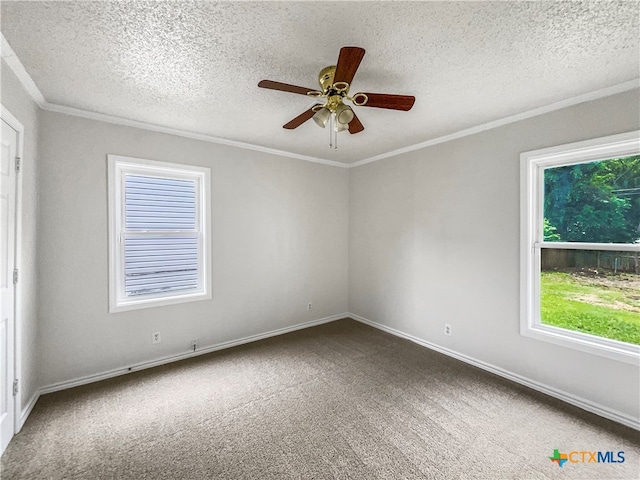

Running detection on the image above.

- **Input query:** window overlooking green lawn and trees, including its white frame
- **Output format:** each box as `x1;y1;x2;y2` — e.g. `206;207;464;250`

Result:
520;132;640;364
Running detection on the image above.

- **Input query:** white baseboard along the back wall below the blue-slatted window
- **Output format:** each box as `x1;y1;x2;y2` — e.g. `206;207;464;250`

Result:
40;313;349;396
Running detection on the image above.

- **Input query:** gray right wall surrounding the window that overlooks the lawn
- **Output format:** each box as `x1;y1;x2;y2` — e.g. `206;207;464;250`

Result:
349;90;640;418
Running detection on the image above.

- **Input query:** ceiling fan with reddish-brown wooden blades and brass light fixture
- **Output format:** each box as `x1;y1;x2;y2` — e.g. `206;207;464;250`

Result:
258;47;416;148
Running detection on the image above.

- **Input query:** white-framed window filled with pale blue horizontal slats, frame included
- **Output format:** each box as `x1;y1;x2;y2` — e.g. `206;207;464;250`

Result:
108;155;211;312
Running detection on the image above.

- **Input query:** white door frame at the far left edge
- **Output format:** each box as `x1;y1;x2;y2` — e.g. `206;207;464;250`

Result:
0;105;25;435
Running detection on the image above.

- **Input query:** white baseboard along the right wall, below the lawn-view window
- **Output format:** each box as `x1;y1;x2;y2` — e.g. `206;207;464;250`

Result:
348;313;640;430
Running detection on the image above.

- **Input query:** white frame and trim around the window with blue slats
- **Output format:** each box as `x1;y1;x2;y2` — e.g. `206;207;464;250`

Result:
107;155;212;313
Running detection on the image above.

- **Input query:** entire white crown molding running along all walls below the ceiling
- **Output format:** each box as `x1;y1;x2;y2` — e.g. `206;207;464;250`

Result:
0;32;640;168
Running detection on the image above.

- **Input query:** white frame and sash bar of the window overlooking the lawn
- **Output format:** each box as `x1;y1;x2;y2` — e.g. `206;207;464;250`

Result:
520;131;640;365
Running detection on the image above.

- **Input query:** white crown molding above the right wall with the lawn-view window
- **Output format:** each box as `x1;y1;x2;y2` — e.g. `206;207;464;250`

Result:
349;79;640;168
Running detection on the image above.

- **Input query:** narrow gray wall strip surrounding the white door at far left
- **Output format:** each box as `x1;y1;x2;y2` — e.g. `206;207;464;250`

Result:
0;60;40;409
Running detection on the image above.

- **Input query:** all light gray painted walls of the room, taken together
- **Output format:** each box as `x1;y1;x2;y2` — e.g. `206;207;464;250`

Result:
2;58;640;426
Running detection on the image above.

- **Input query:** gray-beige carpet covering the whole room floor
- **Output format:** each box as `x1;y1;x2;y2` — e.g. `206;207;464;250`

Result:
0;320;640;480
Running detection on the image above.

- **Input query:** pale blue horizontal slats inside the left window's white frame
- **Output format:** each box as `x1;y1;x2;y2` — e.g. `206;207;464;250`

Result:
124;175;199;297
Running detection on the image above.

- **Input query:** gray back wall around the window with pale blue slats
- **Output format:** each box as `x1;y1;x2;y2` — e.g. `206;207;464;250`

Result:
38;111;349;386
